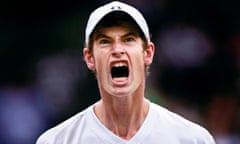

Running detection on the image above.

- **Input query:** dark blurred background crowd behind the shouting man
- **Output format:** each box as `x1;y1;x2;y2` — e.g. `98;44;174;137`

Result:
0;0;240;144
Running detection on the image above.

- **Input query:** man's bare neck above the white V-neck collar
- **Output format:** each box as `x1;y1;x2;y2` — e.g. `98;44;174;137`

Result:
95;97;149;139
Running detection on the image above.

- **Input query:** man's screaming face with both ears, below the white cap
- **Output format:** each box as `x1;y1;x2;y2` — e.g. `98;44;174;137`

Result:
84;26;154;97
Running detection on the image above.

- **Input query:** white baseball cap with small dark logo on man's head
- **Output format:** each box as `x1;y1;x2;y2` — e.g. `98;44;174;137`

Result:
85;1;150;46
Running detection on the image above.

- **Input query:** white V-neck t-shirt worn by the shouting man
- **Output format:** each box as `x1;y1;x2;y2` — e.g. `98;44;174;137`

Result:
37;102;215;144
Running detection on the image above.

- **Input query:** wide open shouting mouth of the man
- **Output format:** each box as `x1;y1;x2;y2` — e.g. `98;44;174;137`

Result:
111;62;129;78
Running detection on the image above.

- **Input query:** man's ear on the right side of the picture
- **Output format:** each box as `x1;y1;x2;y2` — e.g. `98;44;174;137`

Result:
144;42;155;65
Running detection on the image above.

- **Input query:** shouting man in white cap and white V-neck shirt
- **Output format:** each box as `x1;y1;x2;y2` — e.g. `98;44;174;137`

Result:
37;2;215;144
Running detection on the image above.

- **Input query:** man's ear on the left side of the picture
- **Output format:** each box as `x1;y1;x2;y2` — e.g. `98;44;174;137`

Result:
83;48;95;71
